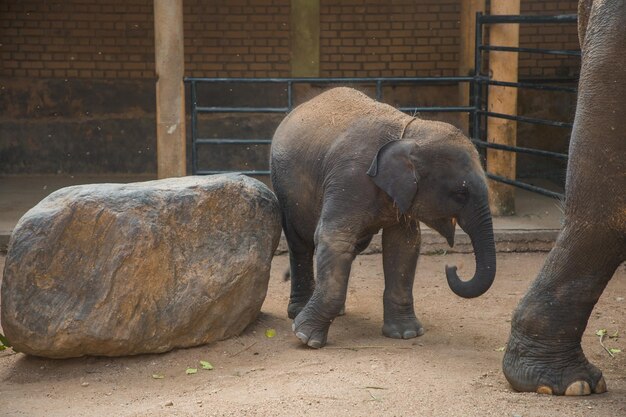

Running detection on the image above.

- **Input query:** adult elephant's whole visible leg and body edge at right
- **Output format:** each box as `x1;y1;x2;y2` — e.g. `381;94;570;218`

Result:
503;0;626;395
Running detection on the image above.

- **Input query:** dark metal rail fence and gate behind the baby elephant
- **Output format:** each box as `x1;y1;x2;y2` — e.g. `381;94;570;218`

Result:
185;13;580;198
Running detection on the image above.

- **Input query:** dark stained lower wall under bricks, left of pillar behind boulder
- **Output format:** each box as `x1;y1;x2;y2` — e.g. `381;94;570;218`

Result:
0;78;156;174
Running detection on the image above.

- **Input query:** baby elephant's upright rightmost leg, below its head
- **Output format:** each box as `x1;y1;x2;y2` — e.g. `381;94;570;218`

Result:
382;222;424;339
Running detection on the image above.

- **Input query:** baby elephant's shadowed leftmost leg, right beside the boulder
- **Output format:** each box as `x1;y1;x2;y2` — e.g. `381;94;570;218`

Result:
283;219;315;319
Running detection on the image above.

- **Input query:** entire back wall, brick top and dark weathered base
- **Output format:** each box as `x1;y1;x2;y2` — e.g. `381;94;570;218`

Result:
0;0;578;174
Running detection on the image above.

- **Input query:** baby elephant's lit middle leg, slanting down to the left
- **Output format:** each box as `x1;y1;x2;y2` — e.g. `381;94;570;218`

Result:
293;236;355;349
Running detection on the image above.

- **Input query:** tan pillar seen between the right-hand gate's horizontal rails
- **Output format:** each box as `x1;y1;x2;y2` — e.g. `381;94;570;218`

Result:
487;0;520;216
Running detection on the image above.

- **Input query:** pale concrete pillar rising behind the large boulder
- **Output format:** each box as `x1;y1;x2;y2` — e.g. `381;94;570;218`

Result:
154;0;186;178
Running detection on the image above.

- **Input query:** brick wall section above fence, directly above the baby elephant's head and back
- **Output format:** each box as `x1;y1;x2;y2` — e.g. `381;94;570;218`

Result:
320;0;459;77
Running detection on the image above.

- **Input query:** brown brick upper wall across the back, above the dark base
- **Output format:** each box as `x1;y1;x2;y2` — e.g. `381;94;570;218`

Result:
0;0;578;79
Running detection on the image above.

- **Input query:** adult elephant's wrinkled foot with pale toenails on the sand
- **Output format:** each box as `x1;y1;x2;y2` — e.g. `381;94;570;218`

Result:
502;330;607;396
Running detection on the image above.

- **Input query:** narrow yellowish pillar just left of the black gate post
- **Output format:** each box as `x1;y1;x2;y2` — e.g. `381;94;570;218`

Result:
459;0;485;134
